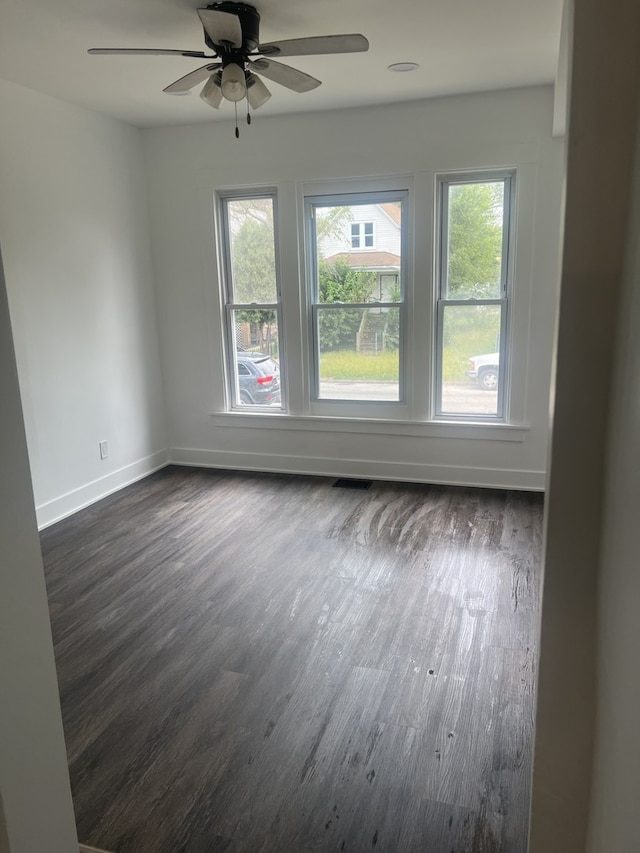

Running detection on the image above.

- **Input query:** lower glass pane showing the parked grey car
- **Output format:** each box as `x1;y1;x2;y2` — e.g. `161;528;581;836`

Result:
231;306;281;407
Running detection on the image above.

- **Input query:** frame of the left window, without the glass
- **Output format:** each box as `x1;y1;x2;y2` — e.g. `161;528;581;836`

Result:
216;187;287;413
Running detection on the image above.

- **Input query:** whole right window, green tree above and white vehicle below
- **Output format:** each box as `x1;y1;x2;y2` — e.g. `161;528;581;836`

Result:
435;174;513;419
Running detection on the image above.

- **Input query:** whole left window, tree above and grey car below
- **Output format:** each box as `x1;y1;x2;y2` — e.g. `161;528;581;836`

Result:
220;193;282;409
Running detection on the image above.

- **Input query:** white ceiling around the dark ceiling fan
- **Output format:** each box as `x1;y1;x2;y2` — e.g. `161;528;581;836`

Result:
0;0;563;126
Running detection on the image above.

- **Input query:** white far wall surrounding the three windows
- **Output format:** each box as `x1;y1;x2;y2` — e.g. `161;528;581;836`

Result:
144;88;563;488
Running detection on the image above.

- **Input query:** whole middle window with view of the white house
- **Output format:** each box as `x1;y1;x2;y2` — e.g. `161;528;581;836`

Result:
307;193;406;402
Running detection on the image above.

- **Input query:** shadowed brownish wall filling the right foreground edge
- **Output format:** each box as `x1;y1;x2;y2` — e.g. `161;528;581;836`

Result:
530;0;640;853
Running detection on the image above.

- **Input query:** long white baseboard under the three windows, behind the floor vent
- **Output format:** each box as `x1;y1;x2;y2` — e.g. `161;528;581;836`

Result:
169;447;545;492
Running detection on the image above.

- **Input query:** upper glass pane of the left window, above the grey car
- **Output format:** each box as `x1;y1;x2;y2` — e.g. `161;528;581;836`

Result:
227;198;277;303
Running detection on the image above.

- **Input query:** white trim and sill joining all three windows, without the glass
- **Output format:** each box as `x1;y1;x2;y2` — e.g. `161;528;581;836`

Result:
212;171;531;432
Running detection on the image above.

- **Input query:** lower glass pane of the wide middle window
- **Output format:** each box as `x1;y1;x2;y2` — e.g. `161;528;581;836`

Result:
318;307;400;401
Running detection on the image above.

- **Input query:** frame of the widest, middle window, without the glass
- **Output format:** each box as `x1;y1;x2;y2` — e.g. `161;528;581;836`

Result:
304;189;410;412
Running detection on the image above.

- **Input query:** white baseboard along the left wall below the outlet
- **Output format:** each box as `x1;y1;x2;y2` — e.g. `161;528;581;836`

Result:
36;450;168;530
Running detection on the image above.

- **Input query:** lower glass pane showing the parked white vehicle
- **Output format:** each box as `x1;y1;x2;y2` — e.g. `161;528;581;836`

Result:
442;305;501;416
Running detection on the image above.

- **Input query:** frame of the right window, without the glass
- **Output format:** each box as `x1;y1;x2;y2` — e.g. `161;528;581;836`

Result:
432;170;515;423
